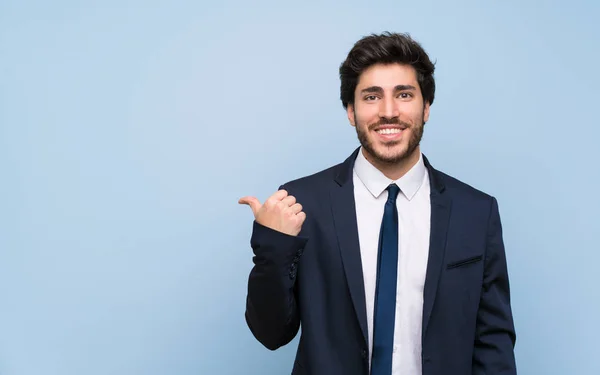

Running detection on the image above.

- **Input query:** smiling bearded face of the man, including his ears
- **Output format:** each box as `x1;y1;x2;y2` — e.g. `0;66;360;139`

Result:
347;64;429;164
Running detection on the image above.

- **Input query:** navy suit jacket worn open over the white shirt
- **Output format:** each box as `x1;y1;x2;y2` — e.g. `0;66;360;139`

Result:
245;149;516;375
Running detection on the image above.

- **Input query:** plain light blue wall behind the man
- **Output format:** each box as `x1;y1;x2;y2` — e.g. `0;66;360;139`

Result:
0;0;600;375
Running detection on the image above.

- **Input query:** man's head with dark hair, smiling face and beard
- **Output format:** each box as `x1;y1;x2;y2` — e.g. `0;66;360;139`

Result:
340;33;435;165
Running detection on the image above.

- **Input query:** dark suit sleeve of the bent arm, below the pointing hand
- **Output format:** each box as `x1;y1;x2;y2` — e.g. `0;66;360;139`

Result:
245;200;308;350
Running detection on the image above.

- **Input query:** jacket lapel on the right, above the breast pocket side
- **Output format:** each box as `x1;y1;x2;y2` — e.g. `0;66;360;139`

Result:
422;158;452;337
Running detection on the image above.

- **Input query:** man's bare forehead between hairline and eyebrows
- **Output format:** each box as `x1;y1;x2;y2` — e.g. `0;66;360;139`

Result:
356;63;418;90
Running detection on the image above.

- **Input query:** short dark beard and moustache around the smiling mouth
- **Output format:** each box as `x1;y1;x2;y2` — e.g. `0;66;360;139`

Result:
354;113;425;165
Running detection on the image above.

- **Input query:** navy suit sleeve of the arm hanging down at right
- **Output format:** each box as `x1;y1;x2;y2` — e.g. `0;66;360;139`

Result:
473;198;517;375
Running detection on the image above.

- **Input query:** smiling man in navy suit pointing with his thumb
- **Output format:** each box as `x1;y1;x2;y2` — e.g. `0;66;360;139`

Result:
239;33;516;375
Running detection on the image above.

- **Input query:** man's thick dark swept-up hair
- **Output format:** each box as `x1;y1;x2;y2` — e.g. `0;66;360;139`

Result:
340;32;435;108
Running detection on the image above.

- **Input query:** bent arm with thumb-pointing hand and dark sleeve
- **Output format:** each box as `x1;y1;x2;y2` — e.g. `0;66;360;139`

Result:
239;187;308;350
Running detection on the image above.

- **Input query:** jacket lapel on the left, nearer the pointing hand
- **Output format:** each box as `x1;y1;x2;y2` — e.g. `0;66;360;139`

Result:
330;149;368;342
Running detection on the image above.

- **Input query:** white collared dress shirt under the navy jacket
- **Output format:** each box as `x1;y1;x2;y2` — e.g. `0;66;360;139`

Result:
353;148;431;375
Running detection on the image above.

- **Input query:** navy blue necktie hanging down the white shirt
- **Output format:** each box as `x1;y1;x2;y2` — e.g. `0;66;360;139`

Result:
371;184;400;375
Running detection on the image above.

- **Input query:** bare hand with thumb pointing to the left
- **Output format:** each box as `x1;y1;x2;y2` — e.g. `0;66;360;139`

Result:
238;190;306;236
